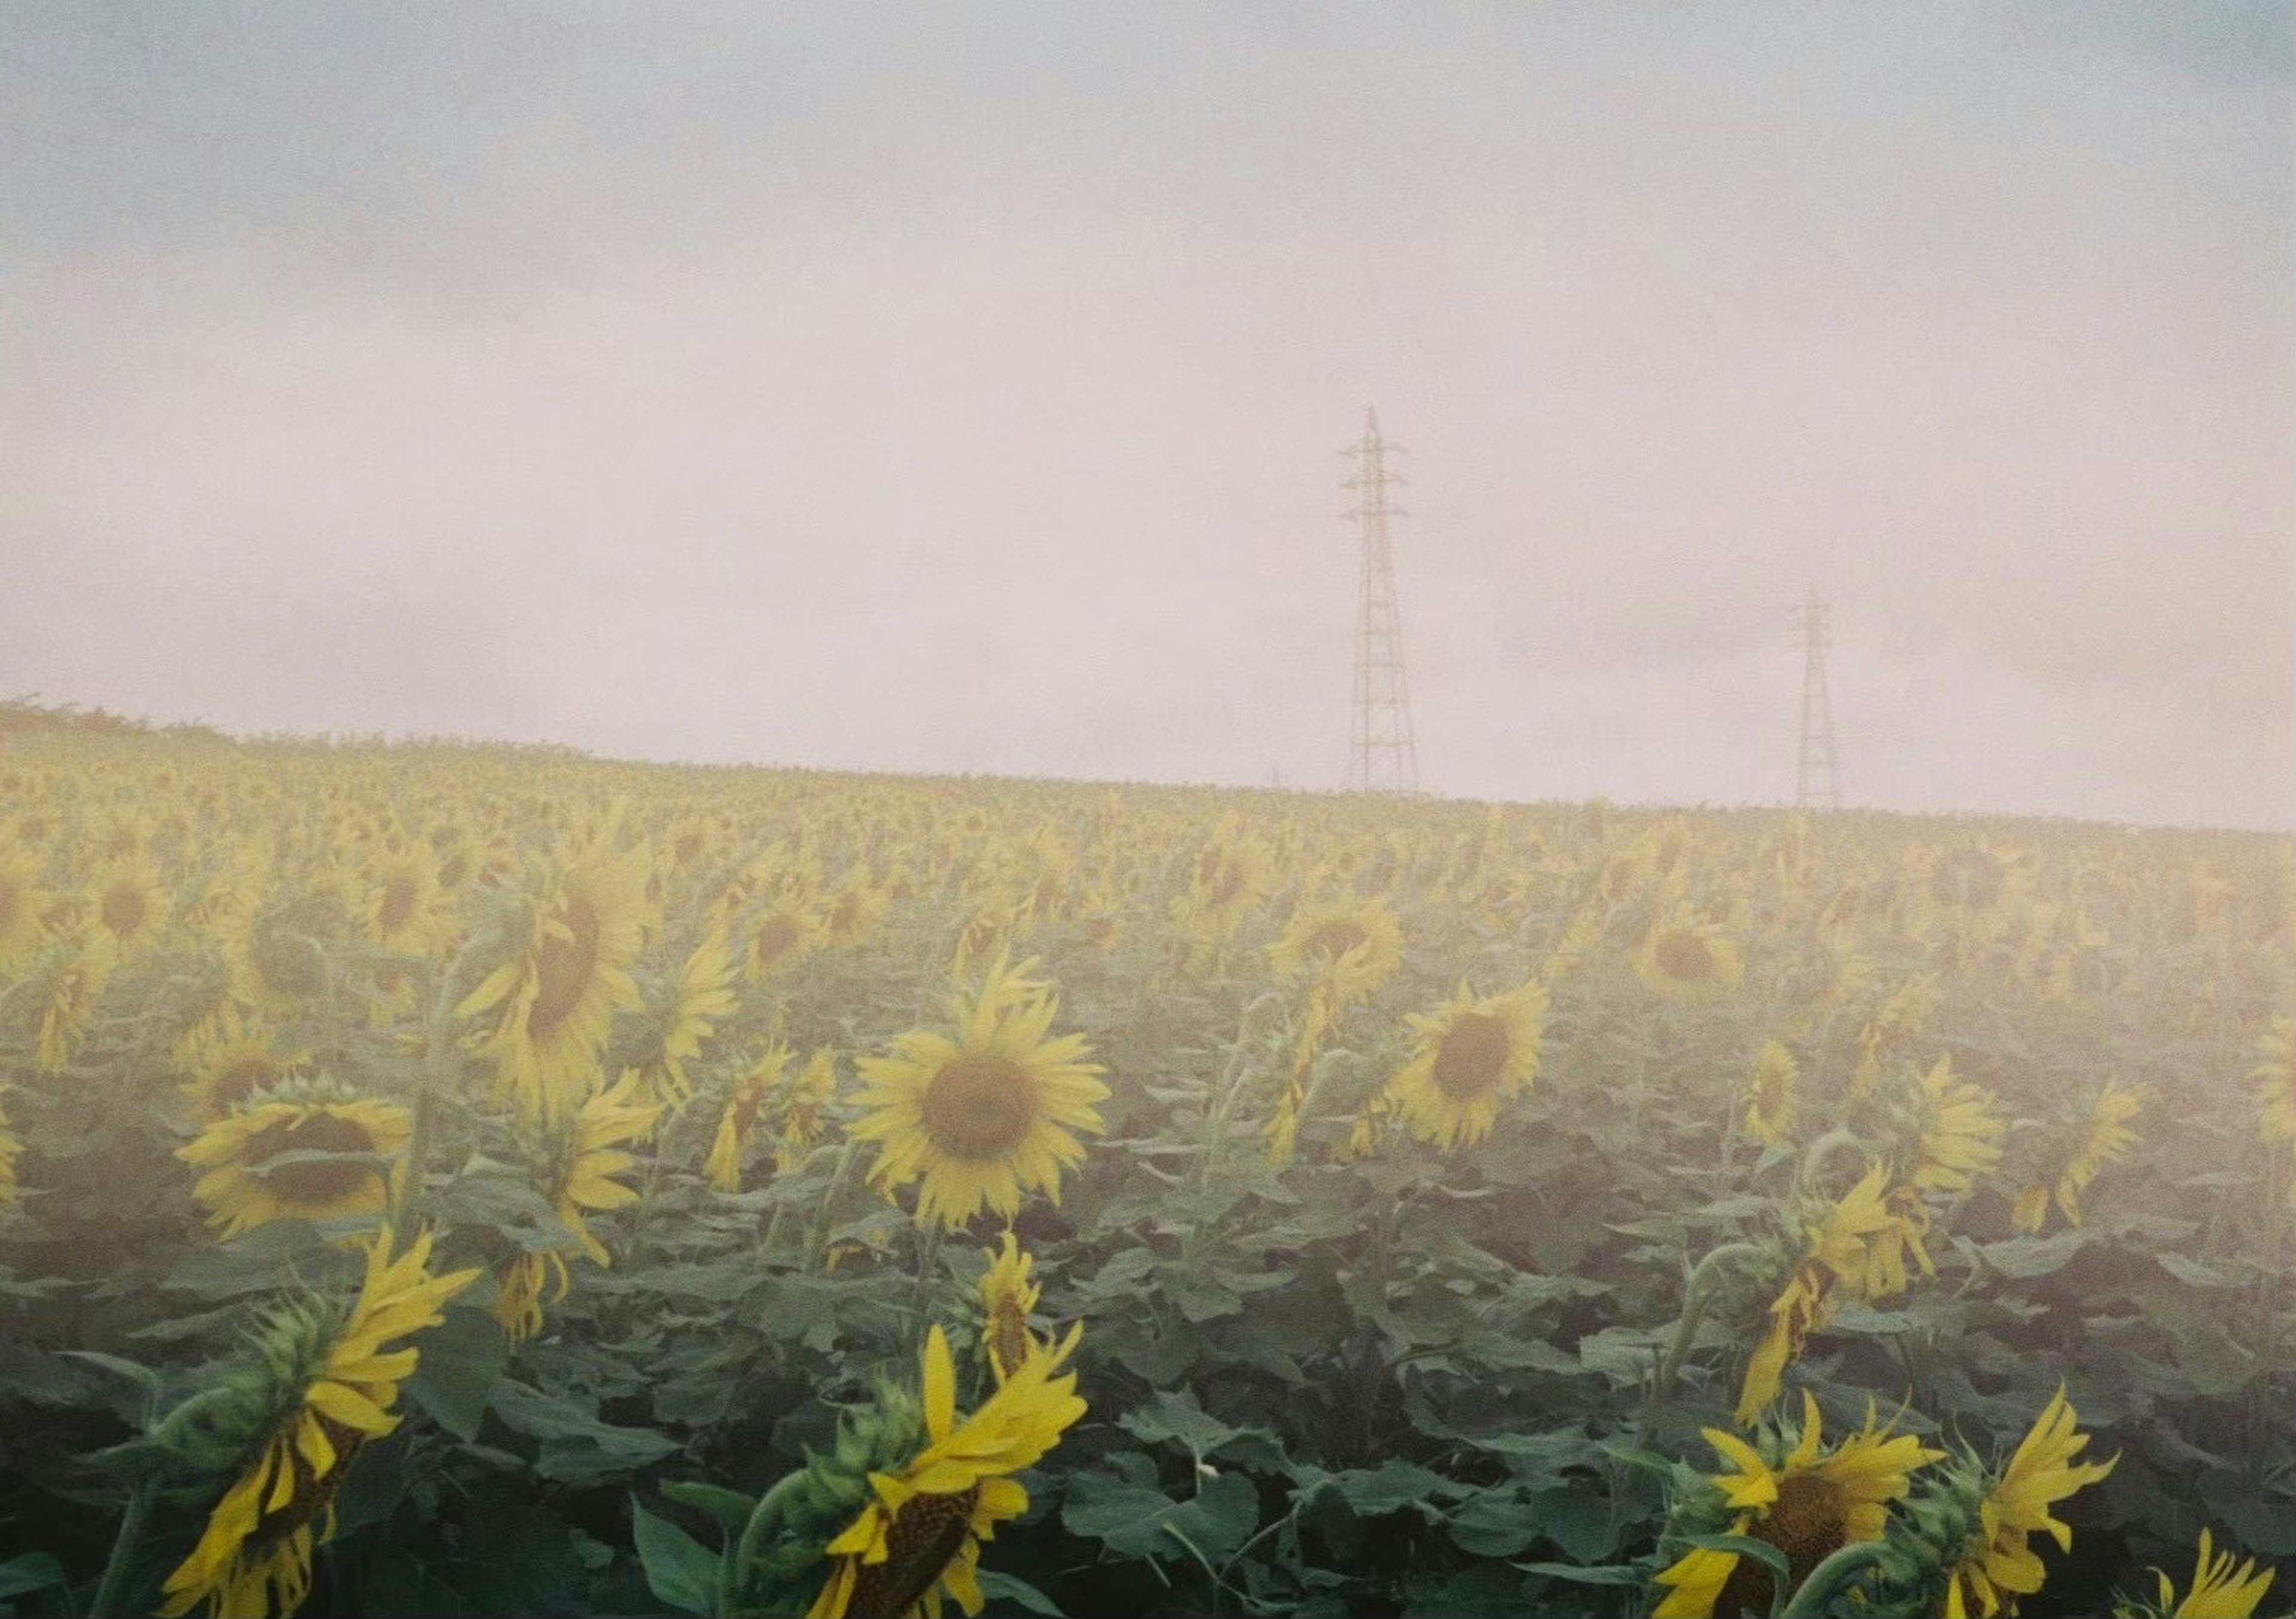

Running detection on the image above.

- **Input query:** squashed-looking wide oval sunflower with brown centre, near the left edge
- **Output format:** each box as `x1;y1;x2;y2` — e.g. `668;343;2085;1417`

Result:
175;1093;413;1238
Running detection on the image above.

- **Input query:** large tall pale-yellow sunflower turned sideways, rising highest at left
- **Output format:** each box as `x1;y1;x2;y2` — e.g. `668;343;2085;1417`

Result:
454;843;650;1120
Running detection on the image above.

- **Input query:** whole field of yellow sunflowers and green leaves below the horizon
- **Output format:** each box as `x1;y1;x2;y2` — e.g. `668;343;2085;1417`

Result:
0;732;2296;1619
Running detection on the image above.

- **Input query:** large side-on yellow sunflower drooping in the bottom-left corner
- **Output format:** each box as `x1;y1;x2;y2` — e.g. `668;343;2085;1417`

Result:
158;1229;478;1619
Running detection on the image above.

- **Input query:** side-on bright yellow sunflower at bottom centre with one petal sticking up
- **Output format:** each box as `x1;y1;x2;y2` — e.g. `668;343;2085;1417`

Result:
806;1325;1083;1619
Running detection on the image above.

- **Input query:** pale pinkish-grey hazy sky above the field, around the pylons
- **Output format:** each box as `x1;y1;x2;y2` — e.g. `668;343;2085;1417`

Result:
0;0;2296;827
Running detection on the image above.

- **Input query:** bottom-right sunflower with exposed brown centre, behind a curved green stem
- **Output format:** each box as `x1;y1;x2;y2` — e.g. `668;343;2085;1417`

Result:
1651;1389;1944;1619
